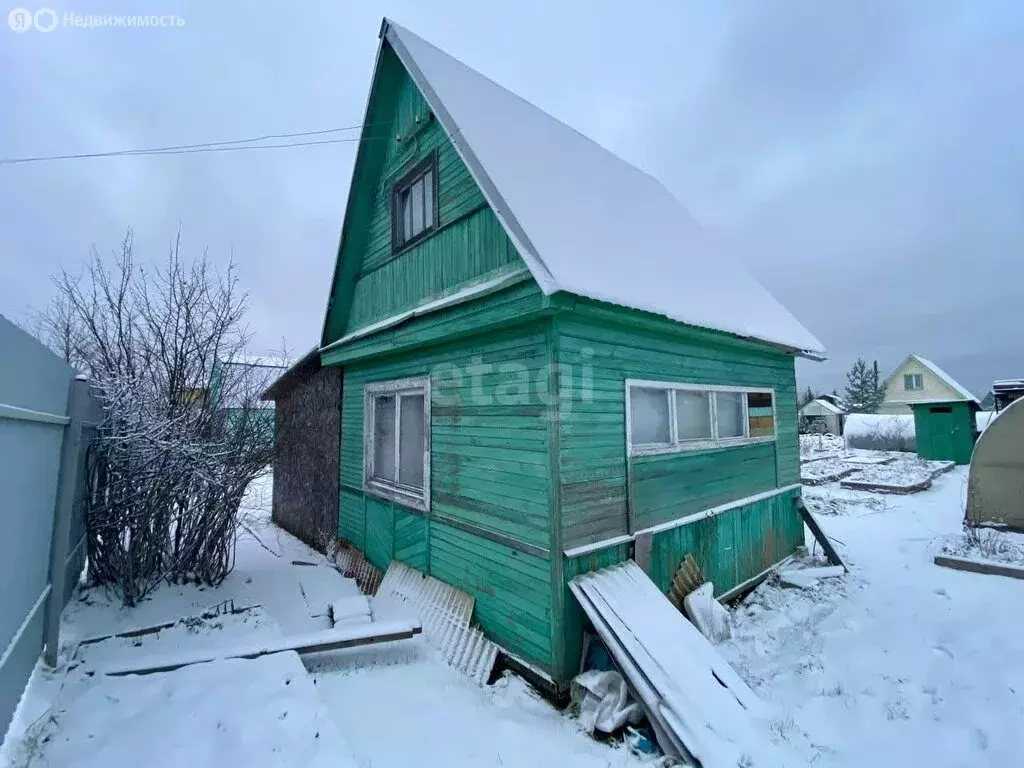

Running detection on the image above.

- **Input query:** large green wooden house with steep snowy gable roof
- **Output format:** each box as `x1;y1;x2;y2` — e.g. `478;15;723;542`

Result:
321;20;821;686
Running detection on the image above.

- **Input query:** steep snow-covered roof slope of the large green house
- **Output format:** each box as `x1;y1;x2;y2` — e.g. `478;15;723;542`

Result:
381;19;823;357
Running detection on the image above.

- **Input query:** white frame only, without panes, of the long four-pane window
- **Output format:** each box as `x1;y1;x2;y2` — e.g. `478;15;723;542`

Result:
626;379;778;457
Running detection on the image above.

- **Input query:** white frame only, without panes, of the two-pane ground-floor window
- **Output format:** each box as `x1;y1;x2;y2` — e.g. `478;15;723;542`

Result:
362;376;430;512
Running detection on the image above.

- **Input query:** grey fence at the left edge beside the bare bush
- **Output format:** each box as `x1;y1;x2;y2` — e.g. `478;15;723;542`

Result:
0;315;94;733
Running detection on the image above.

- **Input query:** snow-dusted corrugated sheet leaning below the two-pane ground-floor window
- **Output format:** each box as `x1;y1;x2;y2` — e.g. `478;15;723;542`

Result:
377;561;498;685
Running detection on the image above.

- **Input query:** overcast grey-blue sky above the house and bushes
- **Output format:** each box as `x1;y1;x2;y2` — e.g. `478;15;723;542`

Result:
0;0;1024;396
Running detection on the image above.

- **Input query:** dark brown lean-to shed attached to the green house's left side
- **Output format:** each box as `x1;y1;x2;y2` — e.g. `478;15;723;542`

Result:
263;347;341;550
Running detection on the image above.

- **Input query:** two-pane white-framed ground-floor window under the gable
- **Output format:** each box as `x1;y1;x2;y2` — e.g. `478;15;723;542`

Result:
364;377;430;510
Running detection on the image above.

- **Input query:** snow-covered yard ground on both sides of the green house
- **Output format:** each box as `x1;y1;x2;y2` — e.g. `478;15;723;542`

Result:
0;468;1024;768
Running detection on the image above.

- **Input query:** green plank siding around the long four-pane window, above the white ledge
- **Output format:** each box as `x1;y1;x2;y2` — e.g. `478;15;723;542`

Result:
555;309;800;548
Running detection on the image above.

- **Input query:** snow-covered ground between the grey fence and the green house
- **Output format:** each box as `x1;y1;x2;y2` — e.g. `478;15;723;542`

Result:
0;476;638;768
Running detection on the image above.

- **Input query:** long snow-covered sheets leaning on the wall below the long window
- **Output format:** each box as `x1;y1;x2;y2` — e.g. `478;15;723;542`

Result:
570;561;781;768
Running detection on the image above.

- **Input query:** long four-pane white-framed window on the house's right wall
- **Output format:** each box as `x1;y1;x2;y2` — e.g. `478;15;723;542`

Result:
626;379;775;456
